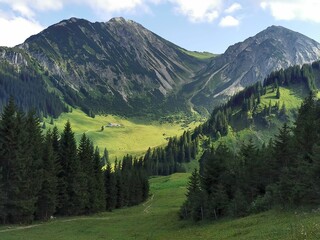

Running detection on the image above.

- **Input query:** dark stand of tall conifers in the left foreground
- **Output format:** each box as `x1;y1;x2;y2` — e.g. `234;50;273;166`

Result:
0;98;149;224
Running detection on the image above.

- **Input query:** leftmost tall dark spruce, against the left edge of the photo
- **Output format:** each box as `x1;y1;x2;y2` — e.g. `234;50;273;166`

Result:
0;99;37;223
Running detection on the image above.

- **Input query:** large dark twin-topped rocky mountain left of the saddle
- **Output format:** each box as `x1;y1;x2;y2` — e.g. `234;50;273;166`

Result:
19;18;205;114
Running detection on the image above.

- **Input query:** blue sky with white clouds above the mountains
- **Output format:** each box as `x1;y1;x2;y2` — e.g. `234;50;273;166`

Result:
0;0;320;54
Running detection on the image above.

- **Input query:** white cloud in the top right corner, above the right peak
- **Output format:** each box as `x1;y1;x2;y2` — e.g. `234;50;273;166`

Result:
260;0;320;23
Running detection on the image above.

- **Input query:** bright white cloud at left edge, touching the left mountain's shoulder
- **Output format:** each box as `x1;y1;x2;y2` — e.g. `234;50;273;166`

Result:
0;17;43;47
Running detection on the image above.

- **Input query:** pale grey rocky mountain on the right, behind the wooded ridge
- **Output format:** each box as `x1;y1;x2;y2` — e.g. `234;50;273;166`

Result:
185;26;320;110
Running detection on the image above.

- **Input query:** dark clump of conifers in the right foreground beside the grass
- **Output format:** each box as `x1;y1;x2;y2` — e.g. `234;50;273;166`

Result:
180;95;320;221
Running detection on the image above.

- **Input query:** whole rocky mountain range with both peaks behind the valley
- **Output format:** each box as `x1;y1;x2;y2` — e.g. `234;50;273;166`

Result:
0;18;320;116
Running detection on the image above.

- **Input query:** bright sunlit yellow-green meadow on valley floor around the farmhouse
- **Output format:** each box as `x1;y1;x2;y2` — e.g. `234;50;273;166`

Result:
46;109;199;161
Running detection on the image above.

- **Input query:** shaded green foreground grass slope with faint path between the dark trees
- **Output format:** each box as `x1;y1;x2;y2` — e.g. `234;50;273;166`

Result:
0;173;320;240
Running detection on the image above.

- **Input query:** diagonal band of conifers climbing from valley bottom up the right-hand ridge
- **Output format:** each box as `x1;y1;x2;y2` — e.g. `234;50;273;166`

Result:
139;61;320;178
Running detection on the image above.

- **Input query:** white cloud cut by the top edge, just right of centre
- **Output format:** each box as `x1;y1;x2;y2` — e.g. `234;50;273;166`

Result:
169;0;223;22
